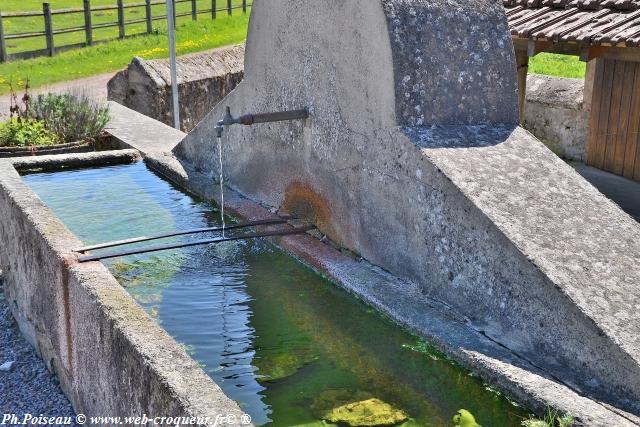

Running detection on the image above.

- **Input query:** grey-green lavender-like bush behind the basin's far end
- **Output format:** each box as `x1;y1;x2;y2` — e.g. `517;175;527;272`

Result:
27;93;110;143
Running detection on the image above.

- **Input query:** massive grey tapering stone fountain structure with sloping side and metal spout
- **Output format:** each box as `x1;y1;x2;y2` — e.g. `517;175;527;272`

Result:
174;0;640;415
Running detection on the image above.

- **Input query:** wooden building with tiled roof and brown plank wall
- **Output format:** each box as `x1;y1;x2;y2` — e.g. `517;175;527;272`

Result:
503;0;640;181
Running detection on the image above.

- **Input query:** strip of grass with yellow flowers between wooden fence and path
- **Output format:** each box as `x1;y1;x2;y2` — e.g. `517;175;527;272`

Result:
0;4;249;94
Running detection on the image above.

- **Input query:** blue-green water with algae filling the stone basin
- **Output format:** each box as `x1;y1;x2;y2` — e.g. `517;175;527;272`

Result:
23;162;528;426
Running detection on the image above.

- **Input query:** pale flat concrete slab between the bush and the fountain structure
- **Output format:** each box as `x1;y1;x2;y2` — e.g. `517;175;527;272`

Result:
105;101;185;154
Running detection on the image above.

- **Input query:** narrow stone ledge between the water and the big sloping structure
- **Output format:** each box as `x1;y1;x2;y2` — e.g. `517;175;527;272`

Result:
145;153;640;427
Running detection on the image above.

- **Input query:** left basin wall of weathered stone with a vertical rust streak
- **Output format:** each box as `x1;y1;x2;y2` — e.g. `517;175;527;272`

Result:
0;160;250;425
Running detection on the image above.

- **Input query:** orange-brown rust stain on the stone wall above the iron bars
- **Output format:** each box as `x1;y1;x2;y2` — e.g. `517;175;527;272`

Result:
280;181;339;241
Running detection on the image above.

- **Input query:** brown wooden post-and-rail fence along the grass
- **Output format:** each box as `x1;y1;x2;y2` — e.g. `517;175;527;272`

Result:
0;0;251;62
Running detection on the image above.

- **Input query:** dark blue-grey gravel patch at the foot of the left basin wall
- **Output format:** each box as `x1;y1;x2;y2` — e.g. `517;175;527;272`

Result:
0;278;75;425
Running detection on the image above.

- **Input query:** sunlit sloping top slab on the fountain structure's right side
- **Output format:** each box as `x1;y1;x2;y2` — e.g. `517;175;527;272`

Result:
405;126;640;378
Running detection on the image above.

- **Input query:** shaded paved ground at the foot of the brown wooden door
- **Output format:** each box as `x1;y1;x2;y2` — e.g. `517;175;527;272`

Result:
570;163;640;221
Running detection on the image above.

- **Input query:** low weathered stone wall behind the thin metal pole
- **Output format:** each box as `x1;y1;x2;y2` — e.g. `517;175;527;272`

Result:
108;45;244;131
